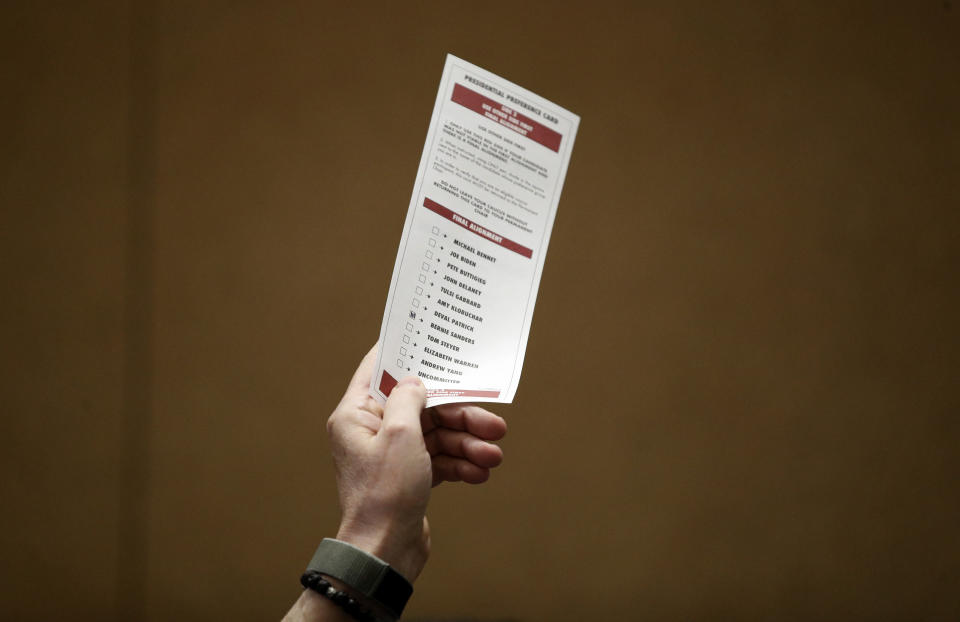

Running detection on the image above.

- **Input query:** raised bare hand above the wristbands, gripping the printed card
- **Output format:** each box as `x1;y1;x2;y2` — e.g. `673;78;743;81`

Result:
327;346;507;582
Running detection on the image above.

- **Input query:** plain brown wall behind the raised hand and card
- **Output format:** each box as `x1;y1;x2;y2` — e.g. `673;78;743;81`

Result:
0;0;960;621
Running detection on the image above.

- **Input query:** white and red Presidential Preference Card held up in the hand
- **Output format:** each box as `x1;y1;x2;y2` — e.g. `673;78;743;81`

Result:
370;55;580;406
